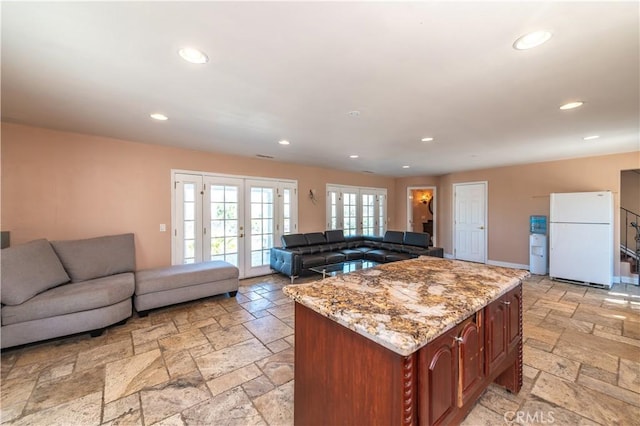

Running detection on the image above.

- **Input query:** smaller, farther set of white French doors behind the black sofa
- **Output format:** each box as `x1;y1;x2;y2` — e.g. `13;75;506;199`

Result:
327;185;387;236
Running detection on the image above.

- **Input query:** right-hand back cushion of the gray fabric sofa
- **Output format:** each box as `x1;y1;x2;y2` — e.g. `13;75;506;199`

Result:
51;234;136;282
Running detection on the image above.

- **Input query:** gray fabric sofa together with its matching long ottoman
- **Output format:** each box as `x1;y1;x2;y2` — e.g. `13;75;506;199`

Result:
0;234;239;348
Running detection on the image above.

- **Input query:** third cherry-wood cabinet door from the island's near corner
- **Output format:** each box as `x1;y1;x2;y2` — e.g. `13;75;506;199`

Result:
485;297;507;376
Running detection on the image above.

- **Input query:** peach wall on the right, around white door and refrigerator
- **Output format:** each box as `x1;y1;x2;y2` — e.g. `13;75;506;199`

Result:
438;152;640;275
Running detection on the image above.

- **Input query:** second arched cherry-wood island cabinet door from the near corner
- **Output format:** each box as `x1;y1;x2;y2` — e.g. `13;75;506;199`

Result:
457;318;484;407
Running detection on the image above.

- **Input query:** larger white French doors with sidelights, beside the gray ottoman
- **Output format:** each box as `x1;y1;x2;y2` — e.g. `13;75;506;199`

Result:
172;172;297;278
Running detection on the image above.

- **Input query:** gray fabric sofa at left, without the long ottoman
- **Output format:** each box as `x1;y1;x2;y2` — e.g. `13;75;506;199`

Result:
0;234;135;348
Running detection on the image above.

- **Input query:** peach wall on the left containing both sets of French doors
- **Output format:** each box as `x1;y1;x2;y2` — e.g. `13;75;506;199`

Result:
1;123;395;268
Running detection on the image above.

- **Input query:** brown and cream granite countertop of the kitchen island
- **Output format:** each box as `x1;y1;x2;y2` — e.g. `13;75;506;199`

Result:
283;256;529;356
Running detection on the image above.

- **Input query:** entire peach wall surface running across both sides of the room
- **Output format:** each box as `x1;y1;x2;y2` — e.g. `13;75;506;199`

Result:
1;123;640;274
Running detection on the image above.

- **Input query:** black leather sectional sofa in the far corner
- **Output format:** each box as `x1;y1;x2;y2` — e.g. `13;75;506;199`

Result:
270;230;444;282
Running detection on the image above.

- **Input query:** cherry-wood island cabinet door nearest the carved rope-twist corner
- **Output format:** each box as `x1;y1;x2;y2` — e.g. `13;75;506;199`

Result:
418;330;458;425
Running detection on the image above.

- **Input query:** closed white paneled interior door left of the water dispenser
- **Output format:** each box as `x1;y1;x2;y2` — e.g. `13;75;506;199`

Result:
453;182;487;263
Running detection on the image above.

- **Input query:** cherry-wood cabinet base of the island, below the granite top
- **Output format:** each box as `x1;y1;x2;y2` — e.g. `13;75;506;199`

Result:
294;286;522;425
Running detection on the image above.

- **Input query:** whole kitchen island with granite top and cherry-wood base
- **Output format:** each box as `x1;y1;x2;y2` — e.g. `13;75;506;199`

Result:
284;256;529;425
